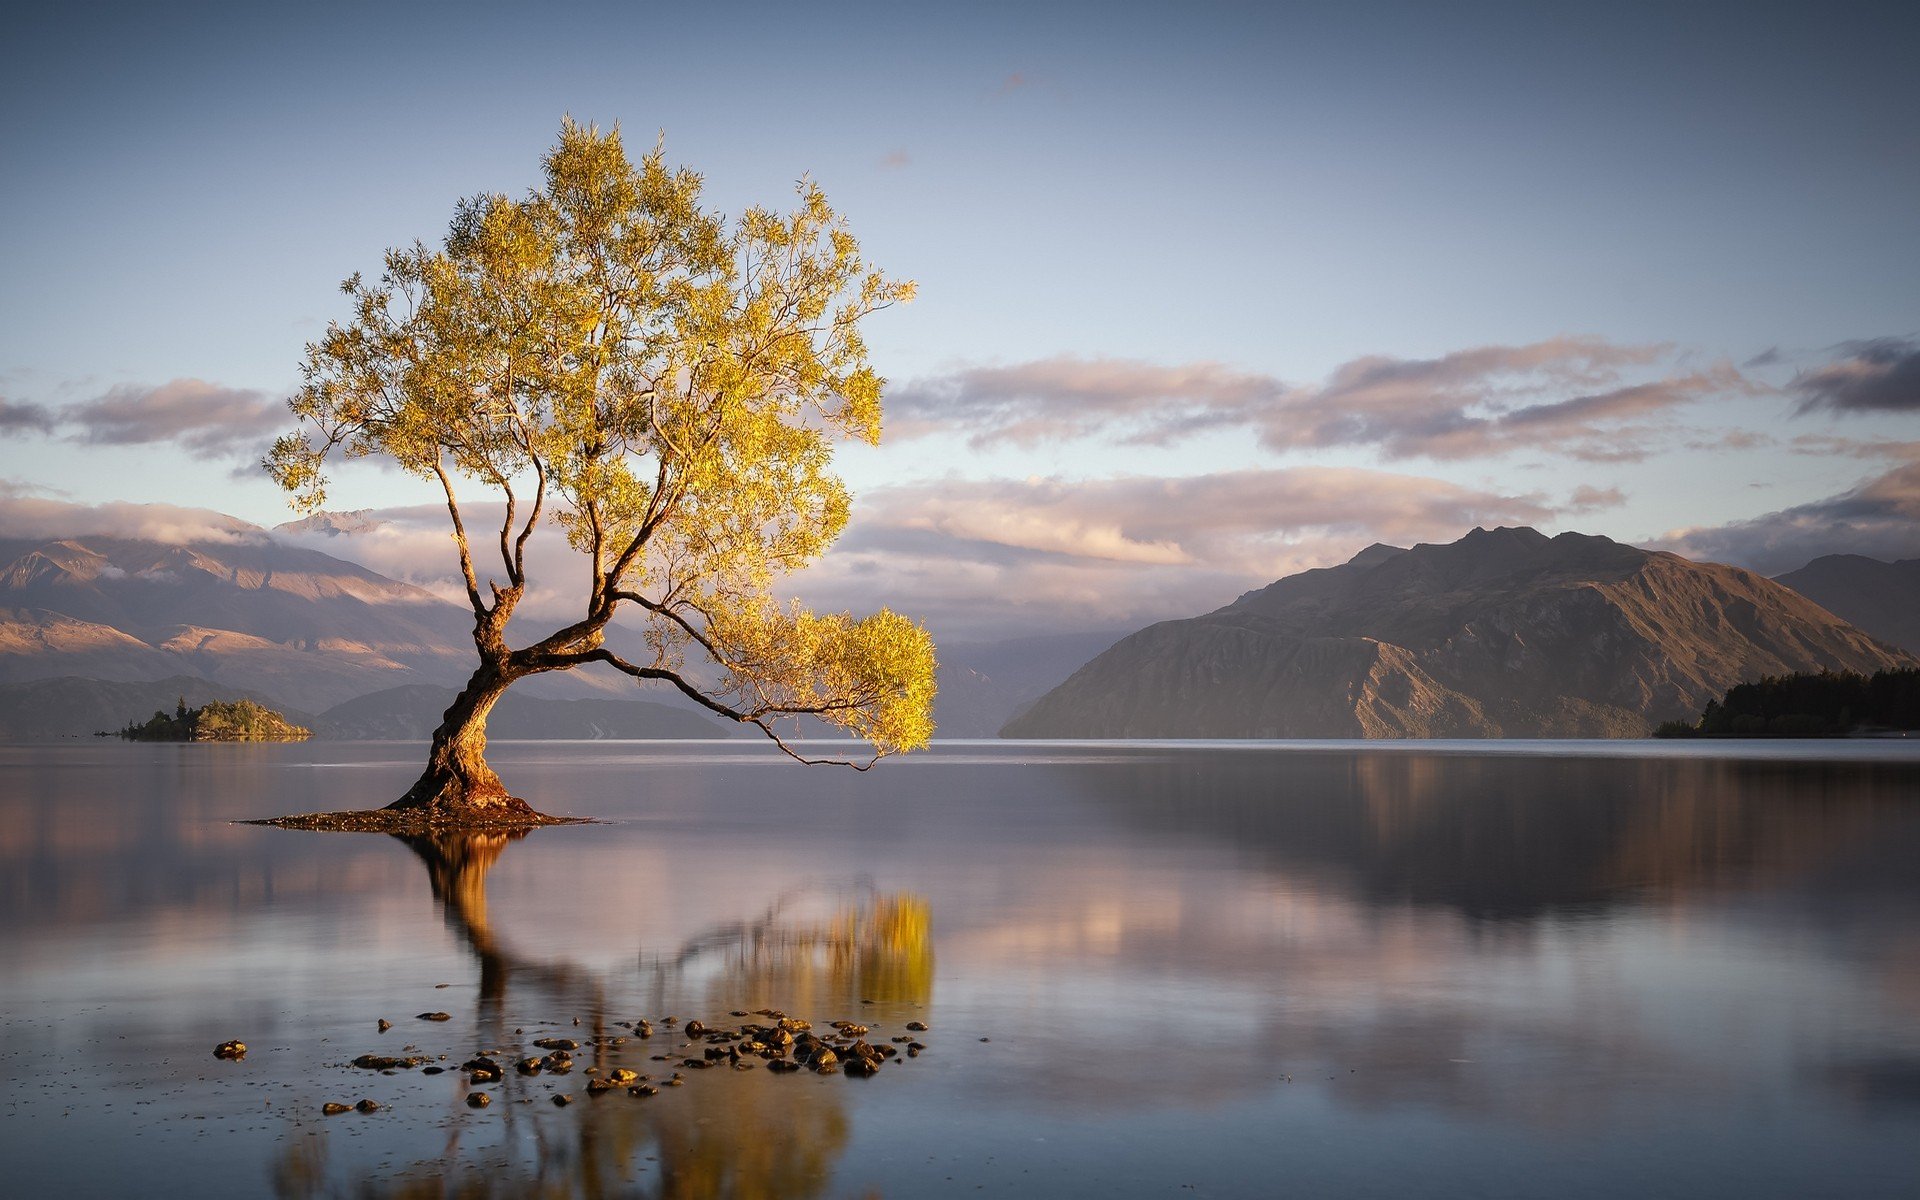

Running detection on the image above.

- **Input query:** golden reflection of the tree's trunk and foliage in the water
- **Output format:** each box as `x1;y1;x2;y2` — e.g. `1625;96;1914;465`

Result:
273;831;933;1200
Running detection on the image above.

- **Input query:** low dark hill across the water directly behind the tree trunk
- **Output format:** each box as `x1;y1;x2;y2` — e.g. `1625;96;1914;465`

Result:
313;685;739;741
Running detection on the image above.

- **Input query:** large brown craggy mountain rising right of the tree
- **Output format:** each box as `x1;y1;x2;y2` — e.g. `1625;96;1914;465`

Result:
1002;528;1920;737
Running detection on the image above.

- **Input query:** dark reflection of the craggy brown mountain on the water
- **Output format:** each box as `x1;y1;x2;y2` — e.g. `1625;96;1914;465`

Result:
1079;751;1912;920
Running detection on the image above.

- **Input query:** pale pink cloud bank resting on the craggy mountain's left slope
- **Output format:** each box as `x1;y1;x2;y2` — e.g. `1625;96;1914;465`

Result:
795;467;1557;639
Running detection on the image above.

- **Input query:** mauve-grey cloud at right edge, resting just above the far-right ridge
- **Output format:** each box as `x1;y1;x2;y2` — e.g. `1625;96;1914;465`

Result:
1653;459;1920;576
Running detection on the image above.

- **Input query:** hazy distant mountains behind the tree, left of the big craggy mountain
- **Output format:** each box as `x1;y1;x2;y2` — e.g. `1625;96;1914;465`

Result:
0;513;1119;739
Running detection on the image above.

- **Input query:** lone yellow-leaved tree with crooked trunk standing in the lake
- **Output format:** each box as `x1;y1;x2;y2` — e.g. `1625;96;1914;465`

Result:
265;119;933;824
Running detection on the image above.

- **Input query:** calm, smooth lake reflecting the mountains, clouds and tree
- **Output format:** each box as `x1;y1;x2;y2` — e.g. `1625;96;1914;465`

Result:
0;741;1920;1198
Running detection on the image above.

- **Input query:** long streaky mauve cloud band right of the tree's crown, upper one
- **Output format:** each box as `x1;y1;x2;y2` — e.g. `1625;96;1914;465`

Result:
889;338;1759;461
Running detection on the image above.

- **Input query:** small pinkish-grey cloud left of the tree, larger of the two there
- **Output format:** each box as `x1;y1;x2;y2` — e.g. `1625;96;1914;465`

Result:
61;378;290;459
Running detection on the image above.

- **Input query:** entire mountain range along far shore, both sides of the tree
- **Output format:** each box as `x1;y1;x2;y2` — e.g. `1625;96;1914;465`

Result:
0;513;1920;739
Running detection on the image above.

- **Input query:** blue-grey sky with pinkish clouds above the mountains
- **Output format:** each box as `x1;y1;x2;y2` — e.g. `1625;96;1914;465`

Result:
0;2;1920;639
